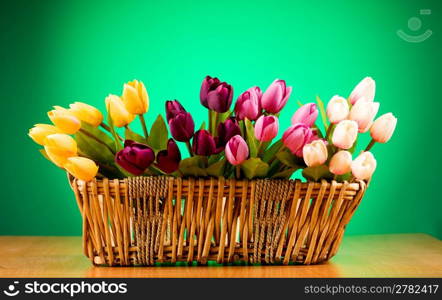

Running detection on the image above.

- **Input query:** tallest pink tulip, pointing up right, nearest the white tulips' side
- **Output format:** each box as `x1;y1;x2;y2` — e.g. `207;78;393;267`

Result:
261;79;292;114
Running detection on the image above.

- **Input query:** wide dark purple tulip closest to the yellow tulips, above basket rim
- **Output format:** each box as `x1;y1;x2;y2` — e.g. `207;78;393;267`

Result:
115;140;155;176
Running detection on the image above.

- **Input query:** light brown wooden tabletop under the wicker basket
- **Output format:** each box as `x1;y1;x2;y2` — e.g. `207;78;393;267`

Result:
0;234;442;277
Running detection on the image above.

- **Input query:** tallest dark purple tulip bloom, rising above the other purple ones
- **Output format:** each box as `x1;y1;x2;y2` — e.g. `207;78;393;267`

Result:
200;76;233;113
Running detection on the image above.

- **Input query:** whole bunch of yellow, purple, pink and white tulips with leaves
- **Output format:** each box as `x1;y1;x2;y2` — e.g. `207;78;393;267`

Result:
29;76;397;181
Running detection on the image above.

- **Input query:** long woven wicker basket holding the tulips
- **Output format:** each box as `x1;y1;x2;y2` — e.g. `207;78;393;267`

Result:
69;176;366;266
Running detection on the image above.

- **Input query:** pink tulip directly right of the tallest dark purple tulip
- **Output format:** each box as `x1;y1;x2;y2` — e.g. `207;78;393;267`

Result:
235;86;262;121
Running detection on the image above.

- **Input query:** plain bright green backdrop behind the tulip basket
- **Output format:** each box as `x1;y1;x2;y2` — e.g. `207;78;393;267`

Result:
0;0;442;238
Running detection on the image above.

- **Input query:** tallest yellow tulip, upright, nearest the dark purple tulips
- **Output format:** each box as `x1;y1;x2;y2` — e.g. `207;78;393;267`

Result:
121;80;149;115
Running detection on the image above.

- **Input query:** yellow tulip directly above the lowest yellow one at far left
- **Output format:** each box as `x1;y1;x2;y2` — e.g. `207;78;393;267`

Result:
44;133;77;167
